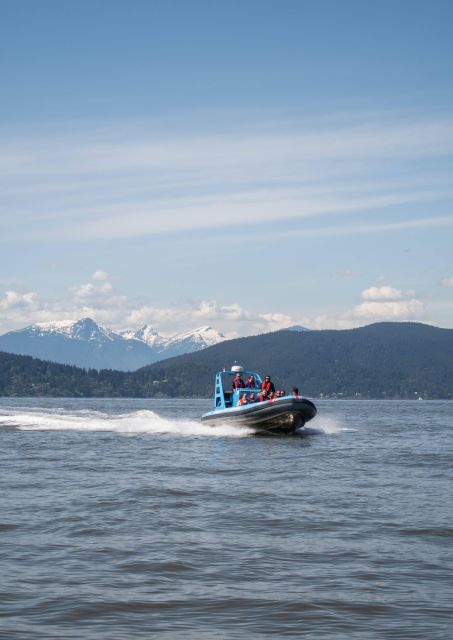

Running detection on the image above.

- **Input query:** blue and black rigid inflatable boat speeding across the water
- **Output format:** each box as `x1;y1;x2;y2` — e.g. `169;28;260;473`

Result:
201;365;316;434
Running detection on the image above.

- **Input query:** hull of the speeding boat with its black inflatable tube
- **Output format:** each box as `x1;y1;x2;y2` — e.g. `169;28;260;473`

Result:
201;397;316;434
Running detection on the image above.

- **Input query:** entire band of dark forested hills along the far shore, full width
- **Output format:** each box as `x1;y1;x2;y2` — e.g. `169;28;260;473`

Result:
0;323;453;398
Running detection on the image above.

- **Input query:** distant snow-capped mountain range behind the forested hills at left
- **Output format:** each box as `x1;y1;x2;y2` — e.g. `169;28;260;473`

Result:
0;318;225;371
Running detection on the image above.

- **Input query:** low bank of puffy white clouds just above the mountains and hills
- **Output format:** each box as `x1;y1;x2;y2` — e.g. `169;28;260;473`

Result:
0;274;426;337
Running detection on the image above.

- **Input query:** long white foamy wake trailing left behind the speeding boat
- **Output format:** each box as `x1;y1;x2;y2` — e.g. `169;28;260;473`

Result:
0;409;253;438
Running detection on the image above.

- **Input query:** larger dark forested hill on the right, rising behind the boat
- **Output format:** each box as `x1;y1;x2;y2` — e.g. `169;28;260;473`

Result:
135;322;453;398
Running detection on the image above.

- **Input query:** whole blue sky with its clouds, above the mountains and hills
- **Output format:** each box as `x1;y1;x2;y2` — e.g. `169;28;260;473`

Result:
0;0;453;336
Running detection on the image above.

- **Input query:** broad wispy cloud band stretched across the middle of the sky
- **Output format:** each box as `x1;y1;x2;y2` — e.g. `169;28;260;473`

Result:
0;114;453;240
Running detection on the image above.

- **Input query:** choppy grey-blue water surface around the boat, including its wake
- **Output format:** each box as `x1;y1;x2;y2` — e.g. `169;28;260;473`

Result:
0;399;453;640
